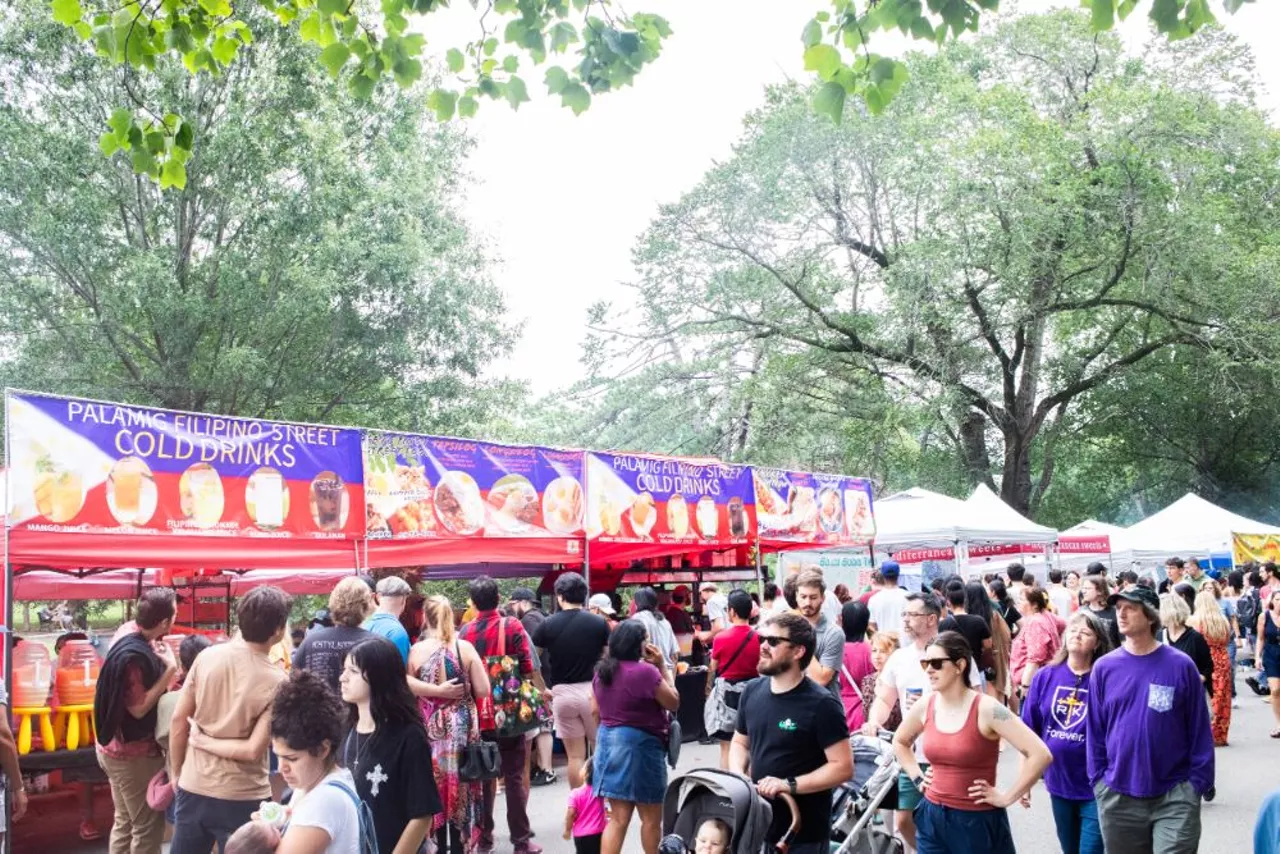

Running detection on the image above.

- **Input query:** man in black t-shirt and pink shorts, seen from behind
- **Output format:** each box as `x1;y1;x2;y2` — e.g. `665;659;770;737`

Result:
534;572;609;789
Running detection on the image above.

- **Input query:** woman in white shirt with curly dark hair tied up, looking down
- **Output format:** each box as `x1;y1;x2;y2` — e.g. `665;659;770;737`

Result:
271;670;360;854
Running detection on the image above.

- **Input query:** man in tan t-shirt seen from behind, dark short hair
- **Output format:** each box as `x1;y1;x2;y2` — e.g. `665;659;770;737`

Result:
169;586;291;854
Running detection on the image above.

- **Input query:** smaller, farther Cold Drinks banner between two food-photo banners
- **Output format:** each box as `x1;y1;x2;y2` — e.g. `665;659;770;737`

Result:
586;452;755;547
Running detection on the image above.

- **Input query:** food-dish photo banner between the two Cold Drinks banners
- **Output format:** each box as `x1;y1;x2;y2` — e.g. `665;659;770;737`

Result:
365;430;584;539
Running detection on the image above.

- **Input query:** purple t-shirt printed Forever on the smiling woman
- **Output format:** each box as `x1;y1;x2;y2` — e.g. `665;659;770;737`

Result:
1023;663;1093;800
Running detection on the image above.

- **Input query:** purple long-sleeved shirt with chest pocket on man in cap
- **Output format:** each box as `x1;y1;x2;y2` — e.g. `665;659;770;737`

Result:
1085;645;1213;798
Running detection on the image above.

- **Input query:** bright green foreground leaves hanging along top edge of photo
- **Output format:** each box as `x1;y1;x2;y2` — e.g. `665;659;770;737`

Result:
35;0;1249;187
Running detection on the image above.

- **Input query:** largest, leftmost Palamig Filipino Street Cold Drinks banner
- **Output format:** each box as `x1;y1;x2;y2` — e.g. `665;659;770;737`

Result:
5;392;364;539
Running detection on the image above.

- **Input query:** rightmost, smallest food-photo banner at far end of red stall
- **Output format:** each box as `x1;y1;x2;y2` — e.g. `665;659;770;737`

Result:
751;466;876;545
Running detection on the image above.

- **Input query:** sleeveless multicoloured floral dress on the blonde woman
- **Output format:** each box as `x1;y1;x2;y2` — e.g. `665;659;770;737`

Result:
417;644;484;851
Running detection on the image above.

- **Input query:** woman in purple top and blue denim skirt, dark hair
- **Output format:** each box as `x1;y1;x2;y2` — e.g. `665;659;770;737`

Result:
591;620;680;854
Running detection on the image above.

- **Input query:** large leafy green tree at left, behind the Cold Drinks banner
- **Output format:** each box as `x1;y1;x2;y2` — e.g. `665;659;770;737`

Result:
0;0;515;430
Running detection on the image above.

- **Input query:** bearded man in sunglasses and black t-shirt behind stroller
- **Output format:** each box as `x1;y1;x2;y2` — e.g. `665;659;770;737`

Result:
728;613;854;854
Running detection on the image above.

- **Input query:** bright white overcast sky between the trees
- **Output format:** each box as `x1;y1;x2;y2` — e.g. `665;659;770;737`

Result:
431;0;1280;394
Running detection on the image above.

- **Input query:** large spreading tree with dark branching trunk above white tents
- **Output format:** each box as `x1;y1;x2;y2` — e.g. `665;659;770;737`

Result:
606;12;1280;511
